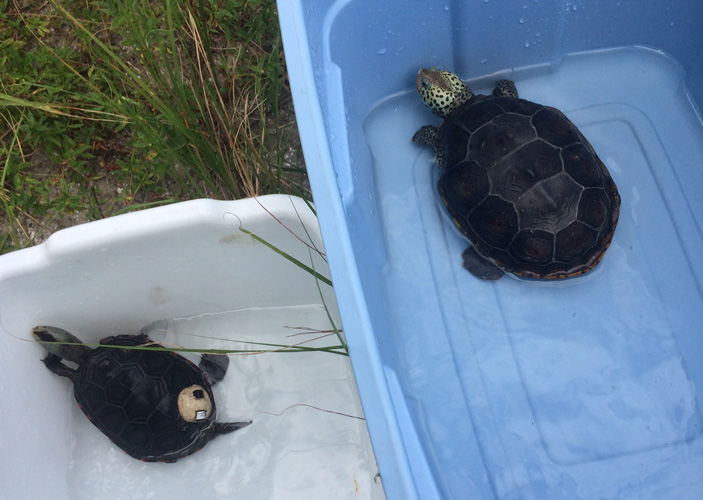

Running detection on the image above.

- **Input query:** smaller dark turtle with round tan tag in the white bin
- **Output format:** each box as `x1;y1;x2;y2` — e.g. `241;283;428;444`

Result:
32;326;251;463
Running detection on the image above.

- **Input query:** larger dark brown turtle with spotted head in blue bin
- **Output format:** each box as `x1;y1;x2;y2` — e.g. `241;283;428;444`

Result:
412;68;620;280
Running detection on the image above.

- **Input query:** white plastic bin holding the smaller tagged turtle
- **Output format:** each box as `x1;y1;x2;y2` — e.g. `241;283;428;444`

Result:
0;196;383;500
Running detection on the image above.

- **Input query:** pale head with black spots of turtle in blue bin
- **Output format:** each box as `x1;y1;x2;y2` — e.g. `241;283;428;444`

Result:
415;68;474;119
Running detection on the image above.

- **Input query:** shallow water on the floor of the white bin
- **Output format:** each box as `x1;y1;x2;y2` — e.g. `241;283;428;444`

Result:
67;305;383;500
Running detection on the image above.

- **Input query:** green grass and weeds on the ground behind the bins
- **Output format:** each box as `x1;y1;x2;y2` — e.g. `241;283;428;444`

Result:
0;0;308;253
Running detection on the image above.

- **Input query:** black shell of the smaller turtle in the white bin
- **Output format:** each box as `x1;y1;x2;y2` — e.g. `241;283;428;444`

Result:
74;335;216;462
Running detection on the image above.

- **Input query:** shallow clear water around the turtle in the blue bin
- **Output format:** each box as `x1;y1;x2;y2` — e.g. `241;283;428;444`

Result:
358;48;703;498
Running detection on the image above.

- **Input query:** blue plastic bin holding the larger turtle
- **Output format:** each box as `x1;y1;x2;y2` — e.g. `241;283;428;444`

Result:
278;0;703;500
